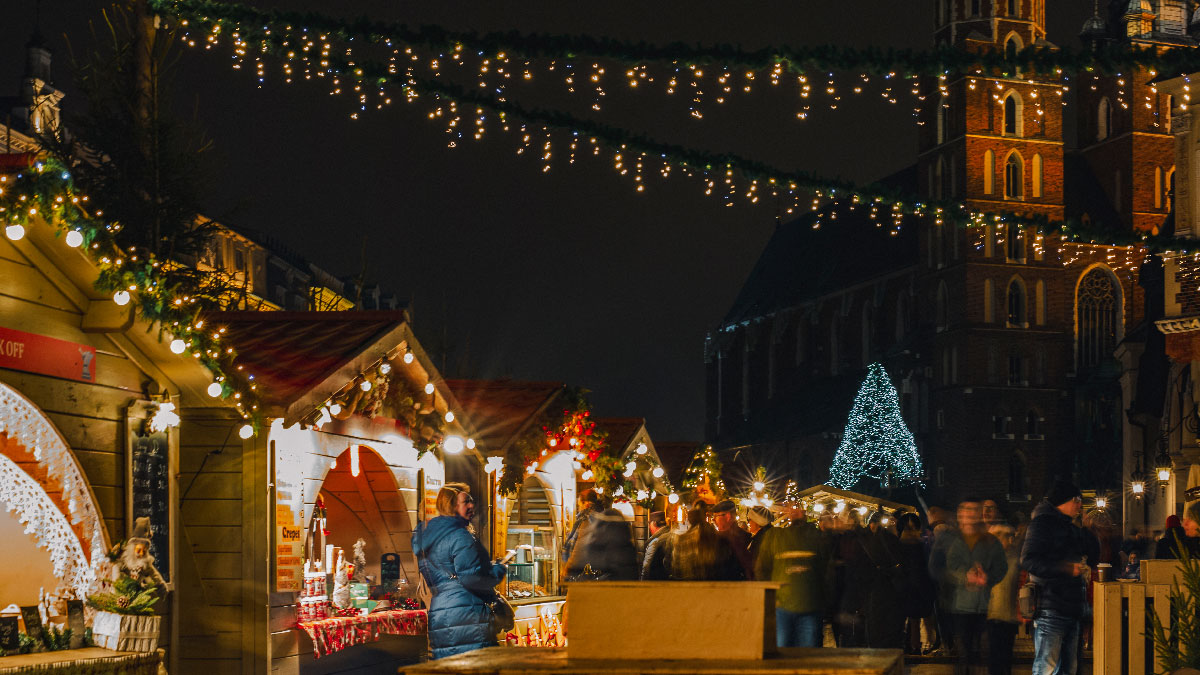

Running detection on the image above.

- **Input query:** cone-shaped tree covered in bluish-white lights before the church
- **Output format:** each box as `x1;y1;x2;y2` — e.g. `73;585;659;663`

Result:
829;363;923;490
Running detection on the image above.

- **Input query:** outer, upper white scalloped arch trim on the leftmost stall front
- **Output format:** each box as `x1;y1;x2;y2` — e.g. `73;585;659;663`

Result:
0;383;108;576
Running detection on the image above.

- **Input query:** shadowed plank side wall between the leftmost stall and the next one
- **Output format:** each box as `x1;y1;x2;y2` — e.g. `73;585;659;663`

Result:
175;408;268;675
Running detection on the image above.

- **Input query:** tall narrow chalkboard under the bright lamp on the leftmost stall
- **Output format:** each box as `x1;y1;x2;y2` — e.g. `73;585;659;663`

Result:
130;431;170;581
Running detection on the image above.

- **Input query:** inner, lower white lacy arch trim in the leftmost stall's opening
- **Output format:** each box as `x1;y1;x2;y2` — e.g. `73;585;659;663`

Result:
0;455;96;598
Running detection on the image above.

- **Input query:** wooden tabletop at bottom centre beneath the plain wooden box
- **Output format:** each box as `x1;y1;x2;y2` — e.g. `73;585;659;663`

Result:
400;645;904;675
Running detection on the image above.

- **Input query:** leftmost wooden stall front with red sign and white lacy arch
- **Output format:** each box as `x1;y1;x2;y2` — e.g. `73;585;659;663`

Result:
0;180;200;671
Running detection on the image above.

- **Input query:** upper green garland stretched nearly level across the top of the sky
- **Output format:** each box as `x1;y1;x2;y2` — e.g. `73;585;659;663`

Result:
150;0;1200;76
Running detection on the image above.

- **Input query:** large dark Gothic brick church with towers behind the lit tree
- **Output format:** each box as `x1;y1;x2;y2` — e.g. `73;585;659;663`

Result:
706;0;1180;510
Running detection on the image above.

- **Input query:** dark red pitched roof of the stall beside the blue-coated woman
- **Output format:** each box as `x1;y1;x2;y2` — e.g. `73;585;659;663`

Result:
208;311;408;423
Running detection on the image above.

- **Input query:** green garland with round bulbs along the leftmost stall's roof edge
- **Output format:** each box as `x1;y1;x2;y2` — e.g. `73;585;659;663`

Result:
0;159;263;432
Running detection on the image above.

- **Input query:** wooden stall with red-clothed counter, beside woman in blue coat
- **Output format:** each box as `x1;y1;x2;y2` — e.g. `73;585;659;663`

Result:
194;311;481;675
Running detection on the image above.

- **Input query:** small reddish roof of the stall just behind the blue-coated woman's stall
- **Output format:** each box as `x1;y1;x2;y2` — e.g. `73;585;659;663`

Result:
445;378;566;453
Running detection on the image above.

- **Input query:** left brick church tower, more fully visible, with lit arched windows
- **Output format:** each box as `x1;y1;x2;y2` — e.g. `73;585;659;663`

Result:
918;0;1141;508
